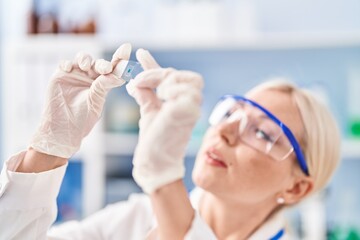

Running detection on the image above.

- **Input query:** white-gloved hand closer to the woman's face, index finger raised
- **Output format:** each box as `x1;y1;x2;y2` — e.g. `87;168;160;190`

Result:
126;49;203;193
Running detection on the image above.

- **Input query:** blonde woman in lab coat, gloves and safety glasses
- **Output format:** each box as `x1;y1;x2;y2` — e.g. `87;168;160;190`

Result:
0;45;340;239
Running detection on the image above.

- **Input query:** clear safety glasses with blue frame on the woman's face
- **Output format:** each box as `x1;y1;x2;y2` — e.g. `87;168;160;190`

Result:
209;95;309;176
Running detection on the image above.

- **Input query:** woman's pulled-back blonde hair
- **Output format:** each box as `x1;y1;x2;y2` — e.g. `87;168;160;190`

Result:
246;79;341;193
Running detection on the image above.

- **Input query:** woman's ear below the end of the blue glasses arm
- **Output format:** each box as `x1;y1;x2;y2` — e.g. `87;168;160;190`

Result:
282;177;314;204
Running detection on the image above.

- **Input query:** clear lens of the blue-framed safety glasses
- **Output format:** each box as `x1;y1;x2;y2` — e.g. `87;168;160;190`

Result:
209;98;293;161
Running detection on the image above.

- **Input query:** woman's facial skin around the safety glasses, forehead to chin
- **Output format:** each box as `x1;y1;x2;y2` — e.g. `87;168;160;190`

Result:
193;90;302;203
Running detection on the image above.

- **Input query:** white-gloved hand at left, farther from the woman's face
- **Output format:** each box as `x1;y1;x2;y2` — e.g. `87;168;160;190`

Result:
30;44;131;158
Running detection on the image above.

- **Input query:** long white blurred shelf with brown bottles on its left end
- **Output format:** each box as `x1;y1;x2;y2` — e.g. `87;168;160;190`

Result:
6;32;360;57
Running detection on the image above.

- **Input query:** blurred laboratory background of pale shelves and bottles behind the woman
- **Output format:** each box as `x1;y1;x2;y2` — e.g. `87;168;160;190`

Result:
0;0;360;240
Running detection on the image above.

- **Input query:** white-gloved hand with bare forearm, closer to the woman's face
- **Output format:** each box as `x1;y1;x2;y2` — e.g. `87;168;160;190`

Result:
127;49;203;239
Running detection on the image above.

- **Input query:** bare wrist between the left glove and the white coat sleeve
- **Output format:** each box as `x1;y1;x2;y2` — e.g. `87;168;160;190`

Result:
16;148;68;173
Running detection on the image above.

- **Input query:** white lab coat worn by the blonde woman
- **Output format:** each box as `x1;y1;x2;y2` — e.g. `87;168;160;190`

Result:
0;152;288;240
